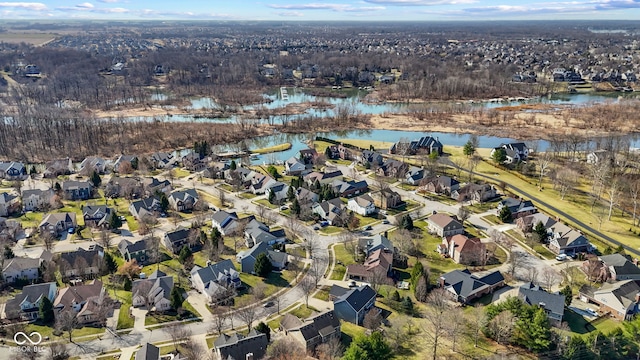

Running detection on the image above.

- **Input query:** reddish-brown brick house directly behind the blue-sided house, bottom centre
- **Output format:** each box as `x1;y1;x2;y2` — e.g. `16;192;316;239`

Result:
346;249;393;284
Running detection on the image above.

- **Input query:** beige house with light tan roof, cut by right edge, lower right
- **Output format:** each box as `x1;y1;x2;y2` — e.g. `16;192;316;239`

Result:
580;280;640;321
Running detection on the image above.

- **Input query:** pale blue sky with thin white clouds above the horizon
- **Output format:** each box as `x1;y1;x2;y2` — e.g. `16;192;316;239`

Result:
0;0;640;21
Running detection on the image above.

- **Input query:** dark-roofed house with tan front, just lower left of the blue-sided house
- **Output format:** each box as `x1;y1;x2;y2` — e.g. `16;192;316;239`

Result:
280;310;342;352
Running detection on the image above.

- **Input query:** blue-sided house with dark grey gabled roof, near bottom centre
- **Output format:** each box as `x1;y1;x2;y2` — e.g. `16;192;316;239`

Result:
333;285;377;325
